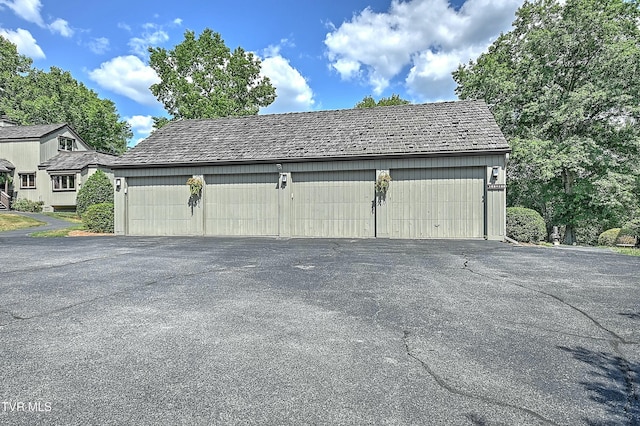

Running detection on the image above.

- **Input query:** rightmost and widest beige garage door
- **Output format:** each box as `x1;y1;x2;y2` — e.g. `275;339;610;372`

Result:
387;167;485;238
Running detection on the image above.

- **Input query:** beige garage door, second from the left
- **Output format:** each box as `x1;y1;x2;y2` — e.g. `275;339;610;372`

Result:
204;173;279;236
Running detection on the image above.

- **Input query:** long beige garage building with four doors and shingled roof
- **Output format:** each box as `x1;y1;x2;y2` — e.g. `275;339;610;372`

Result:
113;101;510;240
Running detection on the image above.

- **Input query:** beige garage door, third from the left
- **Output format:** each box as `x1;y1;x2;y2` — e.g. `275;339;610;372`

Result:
291;170;375;238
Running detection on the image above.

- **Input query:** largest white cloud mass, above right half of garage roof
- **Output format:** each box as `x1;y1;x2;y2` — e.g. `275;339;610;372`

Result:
324;0;524;100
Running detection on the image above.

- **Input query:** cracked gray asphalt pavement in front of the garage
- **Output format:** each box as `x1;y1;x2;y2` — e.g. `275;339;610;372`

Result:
0;234;640;425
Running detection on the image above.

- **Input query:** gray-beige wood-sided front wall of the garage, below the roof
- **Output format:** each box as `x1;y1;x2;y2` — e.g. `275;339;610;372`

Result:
115;154;506;240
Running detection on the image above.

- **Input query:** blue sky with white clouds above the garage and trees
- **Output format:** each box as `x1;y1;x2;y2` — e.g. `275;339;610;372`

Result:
0;0;524;144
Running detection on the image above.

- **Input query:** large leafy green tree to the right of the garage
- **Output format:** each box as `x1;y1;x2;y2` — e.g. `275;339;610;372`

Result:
453;0;640;243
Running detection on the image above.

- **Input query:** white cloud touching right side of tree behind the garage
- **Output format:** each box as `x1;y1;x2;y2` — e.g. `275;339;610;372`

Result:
260;46;315;114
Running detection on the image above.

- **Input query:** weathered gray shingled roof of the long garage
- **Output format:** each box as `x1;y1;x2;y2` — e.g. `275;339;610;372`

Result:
114;101;509;168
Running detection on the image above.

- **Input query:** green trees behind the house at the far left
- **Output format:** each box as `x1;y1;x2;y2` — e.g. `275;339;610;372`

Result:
0;37;133;153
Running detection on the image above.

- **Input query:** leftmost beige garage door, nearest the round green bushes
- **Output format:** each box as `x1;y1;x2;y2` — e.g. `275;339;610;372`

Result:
126;176;199;235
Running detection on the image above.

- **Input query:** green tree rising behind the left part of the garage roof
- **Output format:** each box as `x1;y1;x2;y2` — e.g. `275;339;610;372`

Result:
149;29;276;120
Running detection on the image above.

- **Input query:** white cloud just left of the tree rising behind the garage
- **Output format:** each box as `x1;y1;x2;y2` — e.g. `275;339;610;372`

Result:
89;55;160;106
